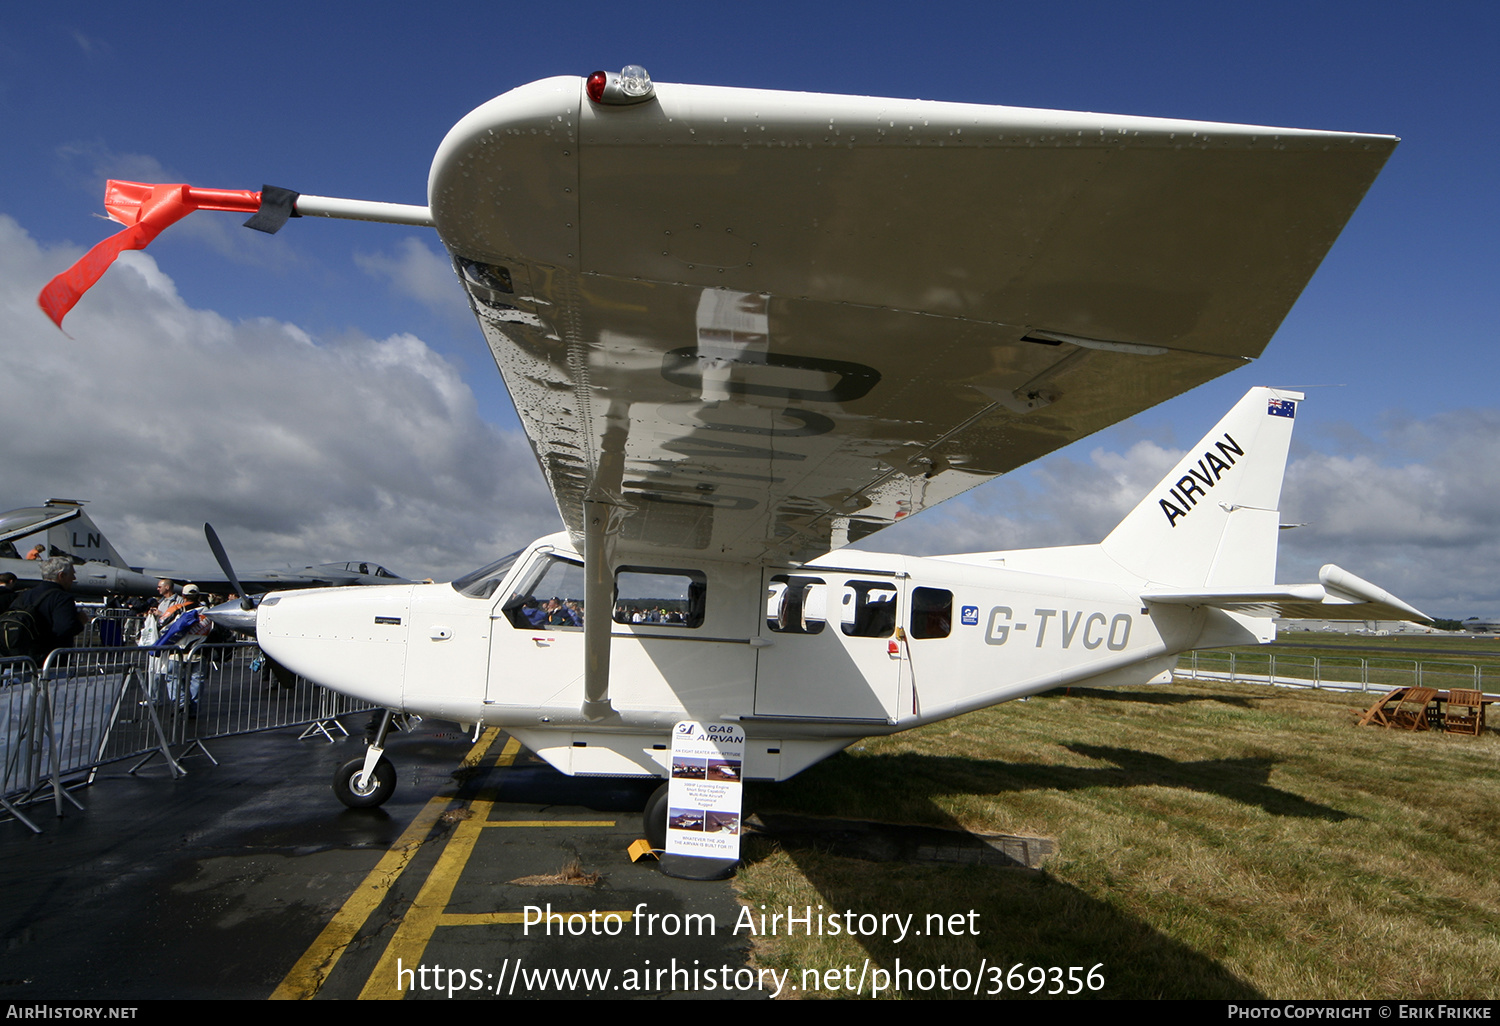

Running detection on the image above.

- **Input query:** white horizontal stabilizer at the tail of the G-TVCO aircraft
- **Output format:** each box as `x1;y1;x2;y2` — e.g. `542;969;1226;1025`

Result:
1142;563;1433;624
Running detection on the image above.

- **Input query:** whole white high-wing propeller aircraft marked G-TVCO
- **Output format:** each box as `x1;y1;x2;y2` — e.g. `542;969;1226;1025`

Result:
42;66;1424;840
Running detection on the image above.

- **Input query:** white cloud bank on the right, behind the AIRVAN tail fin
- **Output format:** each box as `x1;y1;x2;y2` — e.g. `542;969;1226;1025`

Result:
860;410;1500;618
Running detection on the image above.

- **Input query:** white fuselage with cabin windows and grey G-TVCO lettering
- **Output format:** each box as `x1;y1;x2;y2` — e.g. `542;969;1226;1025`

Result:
258;534;1254;780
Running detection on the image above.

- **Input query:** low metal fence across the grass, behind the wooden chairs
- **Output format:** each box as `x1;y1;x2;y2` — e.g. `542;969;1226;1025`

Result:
1175;651;1485;692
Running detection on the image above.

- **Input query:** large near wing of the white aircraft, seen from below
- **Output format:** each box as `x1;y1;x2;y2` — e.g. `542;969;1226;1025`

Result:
429;78;1395;561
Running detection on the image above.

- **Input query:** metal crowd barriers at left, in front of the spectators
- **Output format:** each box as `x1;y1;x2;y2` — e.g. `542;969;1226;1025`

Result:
0;642;374;833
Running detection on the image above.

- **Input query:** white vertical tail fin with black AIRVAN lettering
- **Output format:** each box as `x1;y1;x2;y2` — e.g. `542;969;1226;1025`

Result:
1103;389;1302;588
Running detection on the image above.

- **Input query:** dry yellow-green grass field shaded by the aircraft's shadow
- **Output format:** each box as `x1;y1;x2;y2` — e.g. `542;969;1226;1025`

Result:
740;672;1500;999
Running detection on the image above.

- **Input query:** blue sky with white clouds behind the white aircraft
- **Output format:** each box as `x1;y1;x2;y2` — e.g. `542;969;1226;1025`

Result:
0;3;1500;615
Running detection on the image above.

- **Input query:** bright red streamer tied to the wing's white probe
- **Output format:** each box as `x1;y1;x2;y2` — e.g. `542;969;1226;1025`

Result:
36;180;261;327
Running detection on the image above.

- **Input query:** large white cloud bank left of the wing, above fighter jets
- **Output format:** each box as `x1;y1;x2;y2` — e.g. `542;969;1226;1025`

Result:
0;216;558;578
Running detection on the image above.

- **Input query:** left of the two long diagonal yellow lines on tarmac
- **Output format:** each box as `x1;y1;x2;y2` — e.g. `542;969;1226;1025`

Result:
272;728;504;1001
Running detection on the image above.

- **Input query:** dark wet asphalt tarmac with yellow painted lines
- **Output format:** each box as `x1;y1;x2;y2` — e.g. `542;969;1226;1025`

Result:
0;716;750;1002
